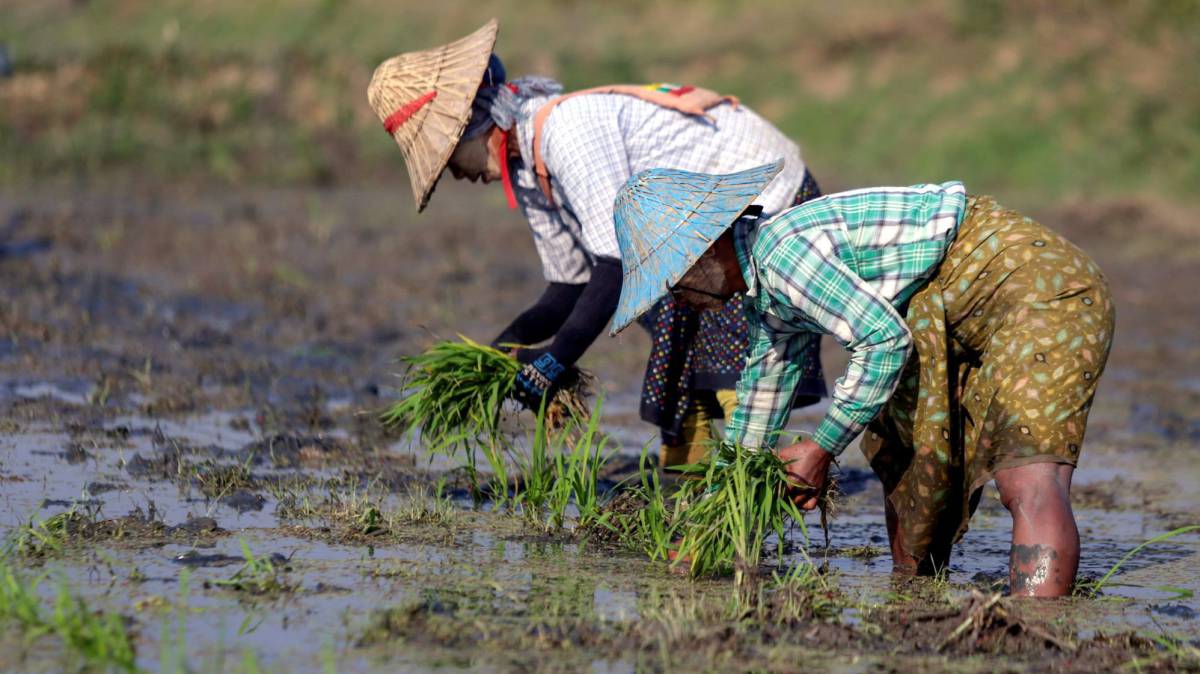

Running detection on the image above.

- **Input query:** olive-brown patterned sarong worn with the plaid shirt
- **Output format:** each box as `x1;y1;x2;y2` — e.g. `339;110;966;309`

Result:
863;197;1114;564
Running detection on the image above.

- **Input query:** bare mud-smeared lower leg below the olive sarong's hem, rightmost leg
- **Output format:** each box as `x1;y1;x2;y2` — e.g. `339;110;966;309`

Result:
996;463;1079;597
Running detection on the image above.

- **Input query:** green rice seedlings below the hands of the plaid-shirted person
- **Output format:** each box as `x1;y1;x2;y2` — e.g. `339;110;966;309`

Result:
672;444;808;585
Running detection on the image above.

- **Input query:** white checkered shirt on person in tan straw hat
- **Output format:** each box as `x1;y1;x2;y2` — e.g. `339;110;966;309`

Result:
512;94;804;283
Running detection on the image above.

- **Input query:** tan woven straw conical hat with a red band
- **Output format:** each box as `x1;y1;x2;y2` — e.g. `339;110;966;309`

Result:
367;19;499;211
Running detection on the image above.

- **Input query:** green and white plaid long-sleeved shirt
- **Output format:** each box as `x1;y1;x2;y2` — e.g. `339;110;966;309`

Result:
726;182;966;455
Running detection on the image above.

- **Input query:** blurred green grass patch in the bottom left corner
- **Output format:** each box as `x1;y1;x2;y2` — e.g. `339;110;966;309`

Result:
0;561;136;672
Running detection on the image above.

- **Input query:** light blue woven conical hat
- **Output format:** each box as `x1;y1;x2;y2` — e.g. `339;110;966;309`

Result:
612;160;784;335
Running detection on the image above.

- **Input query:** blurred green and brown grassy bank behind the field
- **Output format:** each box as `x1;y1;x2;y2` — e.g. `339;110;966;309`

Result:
0;0;1200;203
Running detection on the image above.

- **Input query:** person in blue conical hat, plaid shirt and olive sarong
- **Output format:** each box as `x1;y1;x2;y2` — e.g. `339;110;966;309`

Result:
613;163;1112;596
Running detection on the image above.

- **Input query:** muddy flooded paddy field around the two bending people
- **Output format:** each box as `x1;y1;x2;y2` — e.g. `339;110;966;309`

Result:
0;185;1200;673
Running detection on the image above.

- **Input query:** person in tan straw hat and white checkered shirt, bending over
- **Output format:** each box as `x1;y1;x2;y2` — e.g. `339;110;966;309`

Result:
368;20;824;465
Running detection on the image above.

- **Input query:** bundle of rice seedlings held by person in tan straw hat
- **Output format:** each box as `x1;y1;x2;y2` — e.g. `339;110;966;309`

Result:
380;335;593;455
